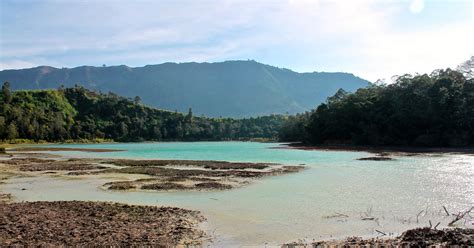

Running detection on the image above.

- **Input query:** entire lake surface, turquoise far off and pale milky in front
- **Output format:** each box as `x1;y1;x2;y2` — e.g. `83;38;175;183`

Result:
1;142;474;246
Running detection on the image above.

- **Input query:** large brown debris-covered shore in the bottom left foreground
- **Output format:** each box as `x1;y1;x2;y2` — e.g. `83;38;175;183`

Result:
0;201;207;247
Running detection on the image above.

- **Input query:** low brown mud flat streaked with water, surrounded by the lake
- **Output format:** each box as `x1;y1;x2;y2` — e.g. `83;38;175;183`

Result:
0;153;303;191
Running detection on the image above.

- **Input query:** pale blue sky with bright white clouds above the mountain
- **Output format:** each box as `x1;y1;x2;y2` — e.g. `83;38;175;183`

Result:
0;0;474;81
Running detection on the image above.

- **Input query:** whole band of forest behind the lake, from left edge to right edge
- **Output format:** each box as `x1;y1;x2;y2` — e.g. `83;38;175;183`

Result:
4;66;474;147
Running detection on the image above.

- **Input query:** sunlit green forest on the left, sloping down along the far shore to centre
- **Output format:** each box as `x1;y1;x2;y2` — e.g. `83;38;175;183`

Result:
0;82;285;141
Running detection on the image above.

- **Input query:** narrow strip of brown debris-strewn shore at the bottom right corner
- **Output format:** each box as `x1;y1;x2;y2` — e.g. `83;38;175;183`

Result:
282;227;474;248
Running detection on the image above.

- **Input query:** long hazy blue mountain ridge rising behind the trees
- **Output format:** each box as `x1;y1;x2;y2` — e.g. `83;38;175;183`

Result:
0;60;369;117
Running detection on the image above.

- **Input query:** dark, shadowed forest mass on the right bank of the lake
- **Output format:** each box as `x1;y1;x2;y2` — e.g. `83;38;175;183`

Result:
280;69;474;147
